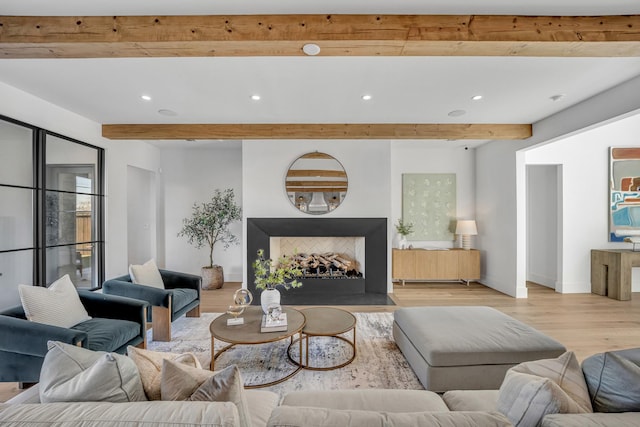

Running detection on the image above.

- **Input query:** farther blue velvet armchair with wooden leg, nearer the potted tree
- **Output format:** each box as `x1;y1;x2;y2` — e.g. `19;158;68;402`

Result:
102;269;202;341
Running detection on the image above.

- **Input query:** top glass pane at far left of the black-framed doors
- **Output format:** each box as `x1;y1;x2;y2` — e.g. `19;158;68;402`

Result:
0;120;33;187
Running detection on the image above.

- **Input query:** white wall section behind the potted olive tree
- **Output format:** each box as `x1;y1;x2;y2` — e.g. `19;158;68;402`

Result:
161;142;244;282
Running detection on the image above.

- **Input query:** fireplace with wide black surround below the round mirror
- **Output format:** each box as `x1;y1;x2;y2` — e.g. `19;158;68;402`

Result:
246;218;393;305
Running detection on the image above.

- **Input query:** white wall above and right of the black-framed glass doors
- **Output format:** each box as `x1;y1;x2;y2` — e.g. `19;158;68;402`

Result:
0;83;160;286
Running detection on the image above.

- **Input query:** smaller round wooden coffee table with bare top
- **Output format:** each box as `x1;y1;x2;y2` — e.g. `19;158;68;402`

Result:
287;307;356;371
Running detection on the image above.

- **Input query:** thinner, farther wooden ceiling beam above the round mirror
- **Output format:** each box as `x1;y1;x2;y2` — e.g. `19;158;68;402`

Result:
102;123;532;140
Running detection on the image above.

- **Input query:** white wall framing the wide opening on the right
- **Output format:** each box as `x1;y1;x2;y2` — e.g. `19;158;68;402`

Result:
476;77;640;297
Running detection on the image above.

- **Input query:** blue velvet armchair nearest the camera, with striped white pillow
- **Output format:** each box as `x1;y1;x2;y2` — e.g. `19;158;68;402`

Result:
0;290;149;383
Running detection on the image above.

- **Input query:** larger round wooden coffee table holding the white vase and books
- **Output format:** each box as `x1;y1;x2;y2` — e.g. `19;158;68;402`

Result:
209;306;306;388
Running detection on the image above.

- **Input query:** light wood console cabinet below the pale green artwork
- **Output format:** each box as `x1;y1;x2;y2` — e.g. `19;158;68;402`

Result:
391;249;480;285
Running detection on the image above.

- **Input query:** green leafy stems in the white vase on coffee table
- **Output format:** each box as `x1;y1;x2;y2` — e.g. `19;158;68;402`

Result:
252;249;302;290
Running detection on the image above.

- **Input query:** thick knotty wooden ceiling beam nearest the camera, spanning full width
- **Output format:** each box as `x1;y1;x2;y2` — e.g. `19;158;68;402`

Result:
0;15;640;58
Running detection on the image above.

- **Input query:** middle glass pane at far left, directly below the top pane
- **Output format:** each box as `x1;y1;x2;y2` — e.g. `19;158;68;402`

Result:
0;186;33;251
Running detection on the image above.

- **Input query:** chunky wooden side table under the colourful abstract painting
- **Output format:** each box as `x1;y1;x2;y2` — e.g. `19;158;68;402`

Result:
591;249;640;301
